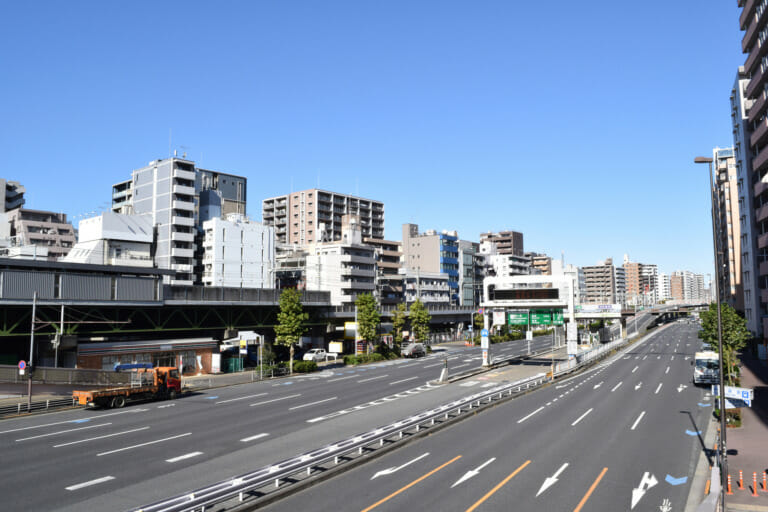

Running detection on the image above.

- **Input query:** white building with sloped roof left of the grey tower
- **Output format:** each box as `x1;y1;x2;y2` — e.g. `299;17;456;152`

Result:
61;212;153;267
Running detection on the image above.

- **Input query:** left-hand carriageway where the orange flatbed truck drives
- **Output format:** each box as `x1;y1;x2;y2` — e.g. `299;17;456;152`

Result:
0;330;552;511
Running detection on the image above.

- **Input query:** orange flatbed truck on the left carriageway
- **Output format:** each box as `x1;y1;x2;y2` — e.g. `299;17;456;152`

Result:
72;363;181;409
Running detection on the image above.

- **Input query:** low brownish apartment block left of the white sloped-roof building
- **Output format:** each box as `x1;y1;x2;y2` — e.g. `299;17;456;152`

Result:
5;208;77;261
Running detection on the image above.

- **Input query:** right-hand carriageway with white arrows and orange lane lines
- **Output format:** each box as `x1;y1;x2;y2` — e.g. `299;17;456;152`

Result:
266;323;713;512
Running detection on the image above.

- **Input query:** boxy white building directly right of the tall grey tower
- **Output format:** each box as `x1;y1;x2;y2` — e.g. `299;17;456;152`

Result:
203;213;275;288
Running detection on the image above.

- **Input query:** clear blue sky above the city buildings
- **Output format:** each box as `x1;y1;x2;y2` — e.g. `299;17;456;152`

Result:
0;0;745;274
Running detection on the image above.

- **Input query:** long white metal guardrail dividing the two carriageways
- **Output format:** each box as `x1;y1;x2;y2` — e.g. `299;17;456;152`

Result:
134;373;546;512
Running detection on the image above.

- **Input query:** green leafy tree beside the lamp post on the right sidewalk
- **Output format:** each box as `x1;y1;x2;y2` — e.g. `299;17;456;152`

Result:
699;304;751;385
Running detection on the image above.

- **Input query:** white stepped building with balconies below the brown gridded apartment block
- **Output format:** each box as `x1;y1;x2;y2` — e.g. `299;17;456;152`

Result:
305;215;376;306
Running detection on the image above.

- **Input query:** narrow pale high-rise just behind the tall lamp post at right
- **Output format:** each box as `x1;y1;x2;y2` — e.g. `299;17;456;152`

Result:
712;148;744;311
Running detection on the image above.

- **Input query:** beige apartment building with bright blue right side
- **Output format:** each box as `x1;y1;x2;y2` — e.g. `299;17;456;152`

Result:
403;224;459;304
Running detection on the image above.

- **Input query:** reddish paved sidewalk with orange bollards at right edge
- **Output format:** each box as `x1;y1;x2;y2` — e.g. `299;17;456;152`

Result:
725;354;768;512
